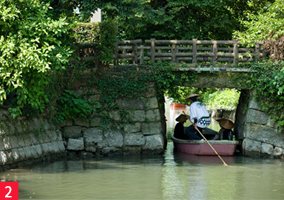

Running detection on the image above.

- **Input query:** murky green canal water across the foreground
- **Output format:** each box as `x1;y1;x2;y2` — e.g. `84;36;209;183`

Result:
0;142;284;200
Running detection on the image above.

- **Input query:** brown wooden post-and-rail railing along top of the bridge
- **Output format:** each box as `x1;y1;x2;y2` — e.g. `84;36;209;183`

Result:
75;39;262;69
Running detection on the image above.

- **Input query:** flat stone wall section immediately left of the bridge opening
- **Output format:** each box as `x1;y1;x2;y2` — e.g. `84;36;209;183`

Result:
60;84;166;155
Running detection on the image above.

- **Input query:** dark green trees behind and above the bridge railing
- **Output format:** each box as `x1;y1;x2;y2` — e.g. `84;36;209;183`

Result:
98;0;274;40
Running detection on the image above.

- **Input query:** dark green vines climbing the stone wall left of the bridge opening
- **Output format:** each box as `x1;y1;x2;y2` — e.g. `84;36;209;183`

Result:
50;62;195;127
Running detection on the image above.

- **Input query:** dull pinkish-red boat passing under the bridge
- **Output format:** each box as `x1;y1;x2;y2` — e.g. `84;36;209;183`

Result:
171;128;239;156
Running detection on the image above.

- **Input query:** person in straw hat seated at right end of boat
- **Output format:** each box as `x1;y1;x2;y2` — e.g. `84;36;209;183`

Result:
216;119;235;140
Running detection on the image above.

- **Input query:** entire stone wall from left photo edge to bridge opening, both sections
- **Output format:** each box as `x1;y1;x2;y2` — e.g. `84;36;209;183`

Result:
0;81;166;169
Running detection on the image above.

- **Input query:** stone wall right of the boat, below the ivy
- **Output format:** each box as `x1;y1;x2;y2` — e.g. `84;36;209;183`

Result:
235;90;284;158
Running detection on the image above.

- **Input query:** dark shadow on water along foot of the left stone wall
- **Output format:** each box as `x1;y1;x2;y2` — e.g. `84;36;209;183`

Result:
6;155;164;174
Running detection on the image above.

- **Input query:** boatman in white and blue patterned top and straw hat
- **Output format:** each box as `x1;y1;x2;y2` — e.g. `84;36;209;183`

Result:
185;94;211;140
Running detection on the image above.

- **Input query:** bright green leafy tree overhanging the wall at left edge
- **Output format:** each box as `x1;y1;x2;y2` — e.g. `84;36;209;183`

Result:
0;0;72;116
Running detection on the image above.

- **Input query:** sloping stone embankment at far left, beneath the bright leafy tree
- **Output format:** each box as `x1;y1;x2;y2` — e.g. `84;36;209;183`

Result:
0;111;65;169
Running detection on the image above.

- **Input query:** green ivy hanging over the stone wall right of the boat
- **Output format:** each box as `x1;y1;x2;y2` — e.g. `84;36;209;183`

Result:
243;61;284;129
